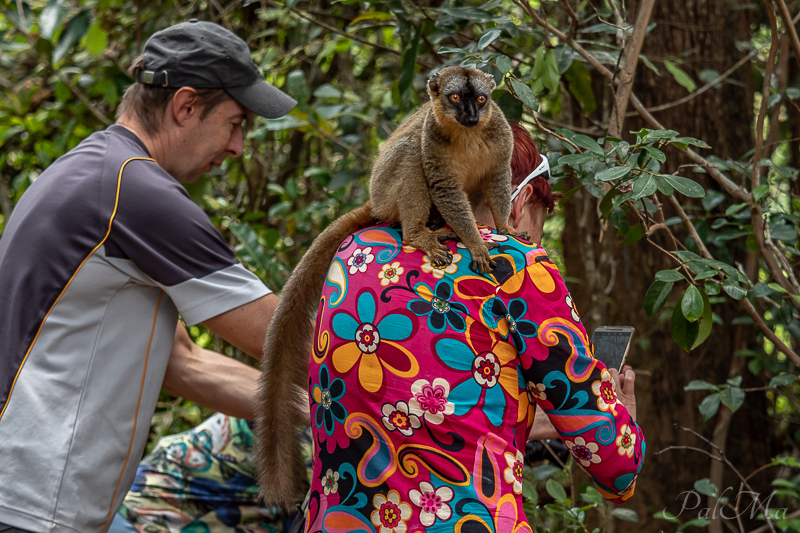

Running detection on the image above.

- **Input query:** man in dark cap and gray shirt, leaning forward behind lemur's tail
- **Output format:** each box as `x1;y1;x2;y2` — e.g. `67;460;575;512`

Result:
0;20;295;533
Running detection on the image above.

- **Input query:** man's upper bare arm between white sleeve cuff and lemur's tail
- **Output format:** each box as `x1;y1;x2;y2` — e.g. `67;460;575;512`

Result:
203;294;280;359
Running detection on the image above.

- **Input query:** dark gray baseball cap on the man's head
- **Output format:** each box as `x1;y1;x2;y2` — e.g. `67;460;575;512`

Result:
137;19;297;118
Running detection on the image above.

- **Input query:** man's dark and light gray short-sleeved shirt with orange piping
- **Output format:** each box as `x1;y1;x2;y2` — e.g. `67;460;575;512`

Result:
0;126;269;533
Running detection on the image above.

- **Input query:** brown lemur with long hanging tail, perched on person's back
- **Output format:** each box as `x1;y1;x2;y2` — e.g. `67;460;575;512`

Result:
257;67;527;509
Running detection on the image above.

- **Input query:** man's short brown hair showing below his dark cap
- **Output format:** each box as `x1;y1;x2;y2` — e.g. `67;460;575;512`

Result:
116;55;232;133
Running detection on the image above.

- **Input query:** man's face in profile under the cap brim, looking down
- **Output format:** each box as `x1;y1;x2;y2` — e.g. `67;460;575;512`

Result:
176;99;249;183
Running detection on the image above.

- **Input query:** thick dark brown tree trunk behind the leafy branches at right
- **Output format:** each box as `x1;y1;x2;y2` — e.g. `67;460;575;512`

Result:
563;0;769;532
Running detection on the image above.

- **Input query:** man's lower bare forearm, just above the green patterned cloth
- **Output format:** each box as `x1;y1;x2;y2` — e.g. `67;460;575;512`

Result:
164;320;266;420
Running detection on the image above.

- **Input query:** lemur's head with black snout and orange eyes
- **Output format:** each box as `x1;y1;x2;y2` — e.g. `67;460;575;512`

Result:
428;67;495;128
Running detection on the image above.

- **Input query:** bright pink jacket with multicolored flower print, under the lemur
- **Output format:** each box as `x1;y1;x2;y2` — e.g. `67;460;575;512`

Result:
306;225;645;533
